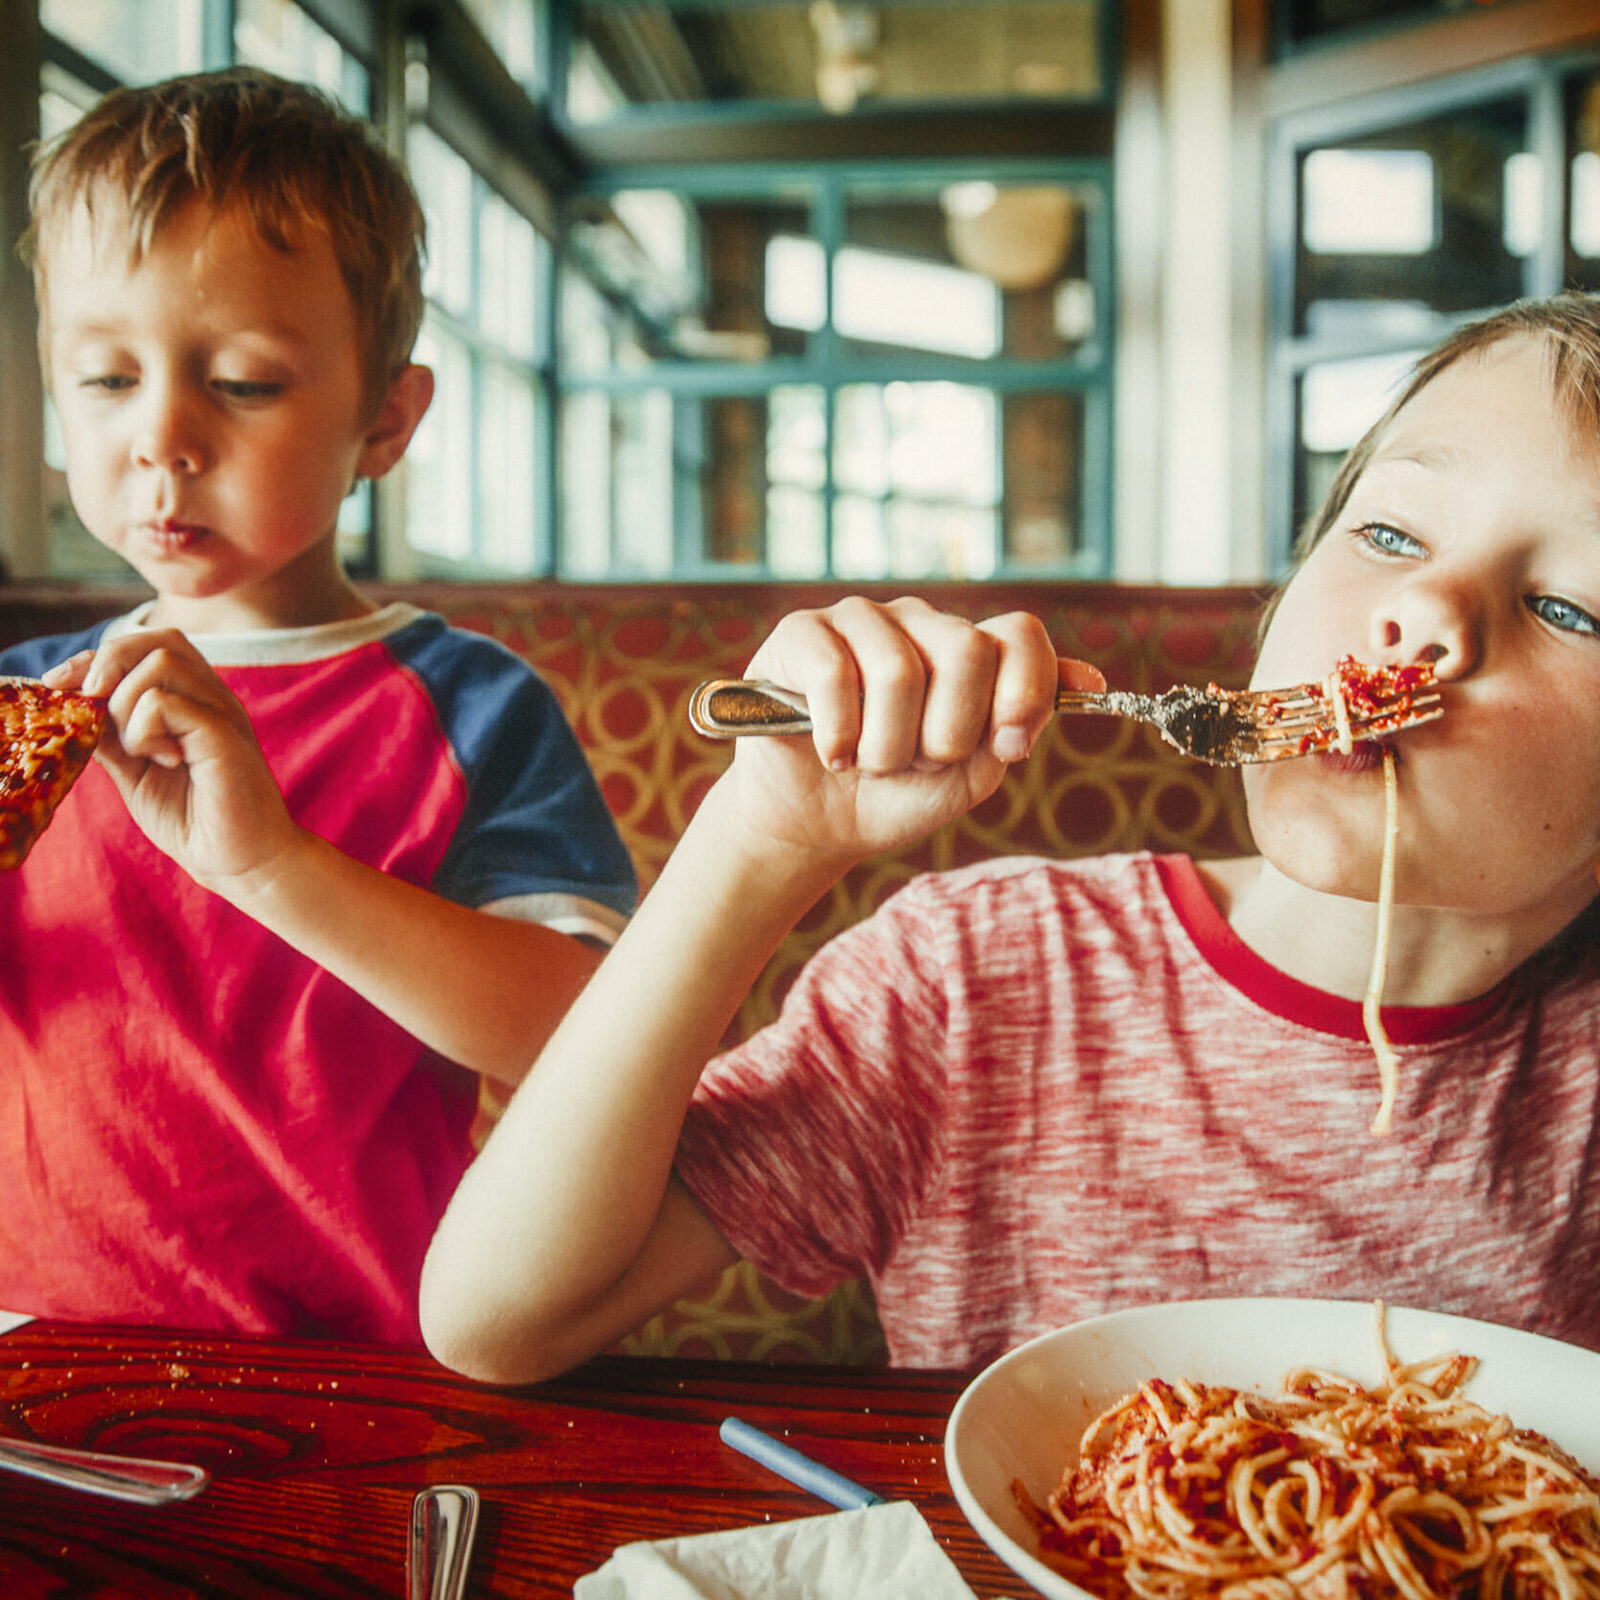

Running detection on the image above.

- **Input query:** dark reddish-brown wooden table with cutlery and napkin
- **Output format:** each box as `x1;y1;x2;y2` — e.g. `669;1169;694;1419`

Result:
0;1323;1026;1600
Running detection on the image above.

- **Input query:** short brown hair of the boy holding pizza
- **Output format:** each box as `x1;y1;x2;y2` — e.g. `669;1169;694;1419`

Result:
22;67;426;410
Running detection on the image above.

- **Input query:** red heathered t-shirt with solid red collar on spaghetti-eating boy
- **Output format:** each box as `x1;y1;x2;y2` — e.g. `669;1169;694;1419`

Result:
678;854;1600;1368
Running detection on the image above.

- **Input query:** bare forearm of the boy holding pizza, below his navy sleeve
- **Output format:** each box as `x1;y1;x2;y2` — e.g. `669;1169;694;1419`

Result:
211;834;602;1083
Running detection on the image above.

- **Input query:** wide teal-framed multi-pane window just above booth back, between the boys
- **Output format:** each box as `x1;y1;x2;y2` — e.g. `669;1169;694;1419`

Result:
558;157;1110;581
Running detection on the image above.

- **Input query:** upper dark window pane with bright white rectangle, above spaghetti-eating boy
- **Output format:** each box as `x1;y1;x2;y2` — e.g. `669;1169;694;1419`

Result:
1294;96;1538;338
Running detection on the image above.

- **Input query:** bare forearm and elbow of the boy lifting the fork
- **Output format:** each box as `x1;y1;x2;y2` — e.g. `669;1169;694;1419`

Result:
422;786;837;1381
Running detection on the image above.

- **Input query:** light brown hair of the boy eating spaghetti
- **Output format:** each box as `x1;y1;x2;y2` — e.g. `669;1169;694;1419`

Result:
1294;290;1600;563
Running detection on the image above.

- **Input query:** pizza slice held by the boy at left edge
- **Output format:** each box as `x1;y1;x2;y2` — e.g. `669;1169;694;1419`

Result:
0;677;106;872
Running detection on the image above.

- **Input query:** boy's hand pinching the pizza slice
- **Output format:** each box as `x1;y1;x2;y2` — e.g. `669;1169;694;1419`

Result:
45;629;299;894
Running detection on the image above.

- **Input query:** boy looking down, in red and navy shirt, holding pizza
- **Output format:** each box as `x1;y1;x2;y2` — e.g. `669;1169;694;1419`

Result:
0;70;635;1341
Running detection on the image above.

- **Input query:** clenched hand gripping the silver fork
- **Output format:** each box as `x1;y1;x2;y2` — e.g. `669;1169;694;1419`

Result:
731;598;1104;862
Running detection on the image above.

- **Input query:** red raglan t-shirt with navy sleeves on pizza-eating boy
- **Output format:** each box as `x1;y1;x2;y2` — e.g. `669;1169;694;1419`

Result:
0;605;635;1341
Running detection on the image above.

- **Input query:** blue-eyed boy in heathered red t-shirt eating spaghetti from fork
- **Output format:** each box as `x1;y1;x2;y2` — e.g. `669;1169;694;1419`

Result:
422;296;1600;1381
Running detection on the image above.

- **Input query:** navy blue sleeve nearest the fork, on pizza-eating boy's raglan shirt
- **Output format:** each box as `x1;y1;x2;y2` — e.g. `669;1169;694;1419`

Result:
387;616;638;915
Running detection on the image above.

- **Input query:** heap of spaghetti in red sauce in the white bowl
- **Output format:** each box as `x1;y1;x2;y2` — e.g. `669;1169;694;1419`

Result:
1013;1306;1600;1600
